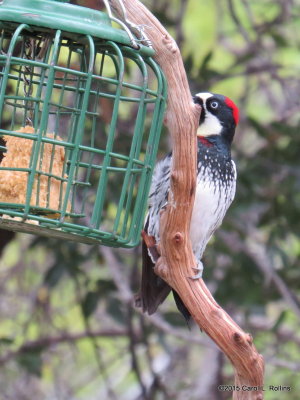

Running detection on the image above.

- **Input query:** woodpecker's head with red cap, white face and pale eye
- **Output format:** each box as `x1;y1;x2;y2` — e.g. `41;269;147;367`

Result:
193;93;239;145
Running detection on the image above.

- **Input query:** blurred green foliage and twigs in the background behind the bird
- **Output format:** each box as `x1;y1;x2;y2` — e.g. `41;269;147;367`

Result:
0;0;300;400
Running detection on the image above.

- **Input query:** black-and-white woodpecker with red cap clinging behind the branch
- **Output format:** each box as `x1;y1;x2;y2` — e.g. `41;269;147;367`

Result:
136;93;239;321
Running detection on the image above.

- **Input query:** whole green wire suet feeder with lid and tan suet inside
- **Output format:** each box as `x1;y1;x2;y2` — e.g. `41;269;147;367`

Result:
0;0;166;247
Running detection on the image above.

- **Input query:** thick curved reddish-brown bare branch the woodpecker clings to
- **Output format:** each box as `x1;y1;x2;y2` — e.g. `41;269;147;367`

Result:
110;0;264;400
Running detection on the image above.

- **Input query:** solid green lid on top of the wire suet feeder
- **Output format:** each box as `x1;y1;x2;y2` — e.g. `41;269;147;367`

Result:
0;0;154;56
